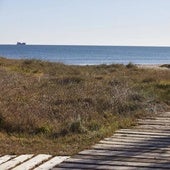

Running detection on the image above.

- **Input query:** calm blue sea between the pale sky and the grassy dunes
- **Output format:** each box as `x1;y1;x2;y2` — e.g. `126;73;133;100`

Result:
0;45;170;65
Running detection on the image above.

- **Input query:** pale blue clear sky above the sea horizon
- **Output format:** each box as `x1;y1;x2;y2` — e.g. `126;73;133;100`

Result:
0;0;170;46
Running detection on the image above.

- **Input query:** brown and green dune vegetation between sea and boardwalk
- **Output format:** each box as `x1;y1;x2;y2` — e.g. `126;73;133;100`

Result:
0;57;170;155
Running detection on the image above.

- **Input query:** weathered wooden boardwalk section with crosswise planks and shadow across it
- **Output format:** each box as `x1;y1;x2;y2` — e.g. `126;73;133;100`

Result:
53;112;170;170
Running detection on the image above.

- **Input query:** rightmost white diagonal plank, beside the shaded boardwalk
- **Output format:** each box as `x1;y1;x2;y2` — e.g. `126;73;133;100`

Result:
34;156;69;170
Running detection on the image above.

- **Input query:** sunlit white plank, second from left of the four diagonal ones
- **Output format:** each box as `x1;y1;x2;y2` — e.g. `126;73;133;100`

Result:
0;155;33;169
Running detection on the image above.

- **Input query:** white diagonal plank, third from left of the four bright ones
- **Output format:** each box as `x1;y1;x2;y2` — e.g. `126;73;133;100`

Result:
12;154;51;170
